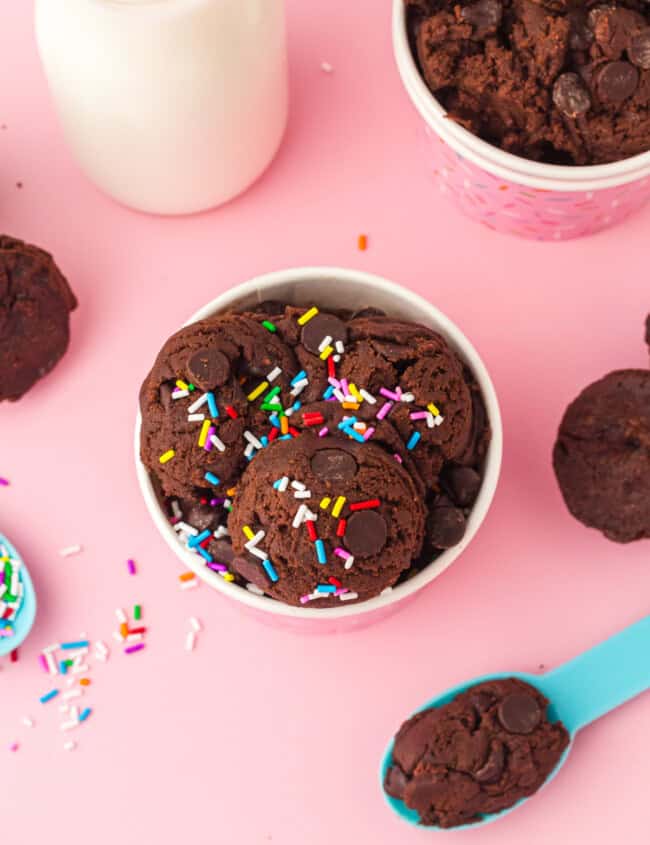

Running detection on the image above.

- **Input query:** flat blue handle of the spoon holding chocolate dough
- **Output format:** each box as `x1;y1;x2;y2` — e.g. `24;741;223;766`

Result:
539;616;650;734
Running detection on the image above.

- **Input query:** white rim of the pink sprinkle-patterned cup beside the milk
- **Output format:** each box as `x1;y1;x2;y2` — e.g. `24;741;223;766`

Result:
393;0;650;192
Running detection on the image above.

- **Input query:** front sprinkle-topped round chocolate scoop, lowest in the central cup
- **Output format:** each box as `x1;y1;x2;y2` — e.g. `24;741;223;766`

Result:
228;431;425;608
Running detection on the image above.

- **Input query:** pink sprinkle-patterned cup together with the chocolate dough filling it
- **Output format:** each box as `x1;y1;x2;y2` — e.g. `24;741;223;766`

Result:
393;0;650;240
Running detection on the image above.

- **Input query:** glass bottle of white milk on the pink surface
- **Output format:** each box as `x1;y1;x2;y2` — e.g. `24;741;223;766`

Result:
36;0;288;214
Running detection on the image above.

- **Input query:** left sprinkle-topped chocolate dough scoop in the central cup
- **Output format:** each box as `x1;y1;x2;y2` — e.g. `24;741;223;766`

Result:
140;314;298;502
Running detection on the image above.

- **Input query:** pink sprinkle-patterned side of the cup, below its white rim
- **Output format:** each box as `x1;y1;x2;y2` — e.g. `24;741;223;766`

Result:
426;127;650;241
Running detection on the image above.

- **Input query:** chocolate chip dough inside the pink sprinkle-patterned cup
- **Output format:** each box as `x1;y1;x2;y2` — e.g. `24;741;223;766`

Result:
405;0;650;165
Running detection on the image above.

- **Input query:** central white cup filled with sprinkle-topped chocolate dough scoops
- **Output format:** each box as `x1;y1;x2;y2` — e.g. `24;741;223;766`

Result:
136;267;502;633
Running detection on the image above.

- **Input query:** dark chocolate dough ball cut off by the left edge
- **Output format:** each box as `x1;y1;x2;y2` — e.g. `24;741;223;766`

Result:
0;235;77;402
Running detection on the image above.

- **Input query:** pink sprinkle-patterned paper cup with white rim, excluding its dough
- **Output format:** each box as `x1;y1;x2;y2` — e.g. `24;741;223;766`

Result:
393;0;650;241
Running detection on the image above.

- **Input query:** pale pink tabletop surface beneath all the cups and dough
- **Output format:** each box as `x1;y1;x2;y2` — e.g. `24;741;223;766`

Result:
0;0;650;845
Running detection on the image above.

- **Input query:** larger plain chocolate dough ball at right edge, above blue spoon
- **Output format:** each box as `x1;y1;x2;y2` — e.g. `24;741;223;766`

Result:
553;322;650;543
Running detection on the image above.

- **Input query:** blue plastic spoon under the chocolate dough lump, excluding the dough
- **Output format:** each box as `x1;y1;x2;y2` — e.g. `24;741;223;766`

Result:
381;616;650;830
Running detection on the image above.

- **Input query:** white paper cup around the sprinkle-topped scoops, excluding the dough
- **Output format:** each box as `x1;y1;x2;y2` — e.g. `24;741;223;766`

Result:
135;267;503;633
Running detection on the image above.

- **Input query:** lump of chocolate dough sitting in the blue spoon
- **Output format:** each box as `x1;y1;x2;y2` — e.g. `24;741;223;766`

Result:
384;678;569;828
